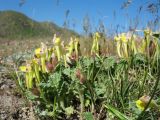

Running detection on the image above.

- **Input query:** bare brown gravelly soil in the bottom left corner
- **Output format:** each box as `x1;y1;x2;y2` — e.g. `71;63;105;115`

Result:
0;59;36;120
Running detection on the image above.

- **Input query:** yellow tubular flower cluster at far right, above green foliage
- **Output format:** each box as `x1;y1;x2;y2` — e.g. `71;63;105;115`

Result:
114;29;159;58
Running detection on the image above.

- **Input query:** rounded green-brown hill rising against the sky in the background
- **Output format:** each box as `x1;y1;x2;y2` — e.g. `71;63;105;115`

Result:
0;11;78;39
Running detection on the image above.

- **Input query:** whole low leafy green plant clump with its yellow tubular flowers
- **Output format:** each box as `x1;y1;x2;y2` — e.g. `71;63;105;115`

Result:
17;29;160;120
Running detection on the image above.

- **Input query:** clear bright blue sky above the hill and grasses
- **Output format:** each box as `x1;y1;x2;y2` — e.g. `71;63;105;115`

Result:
0;0;158;33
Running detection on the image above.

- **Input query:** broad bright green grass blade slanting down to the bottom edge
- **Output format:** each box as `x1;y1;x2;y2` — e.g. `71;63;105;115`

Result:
104;105;133;120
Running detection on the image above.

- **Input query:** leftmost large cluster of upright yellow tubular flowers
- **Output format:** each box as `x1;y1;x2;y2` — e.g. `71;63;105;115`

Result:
20;35;81;89
